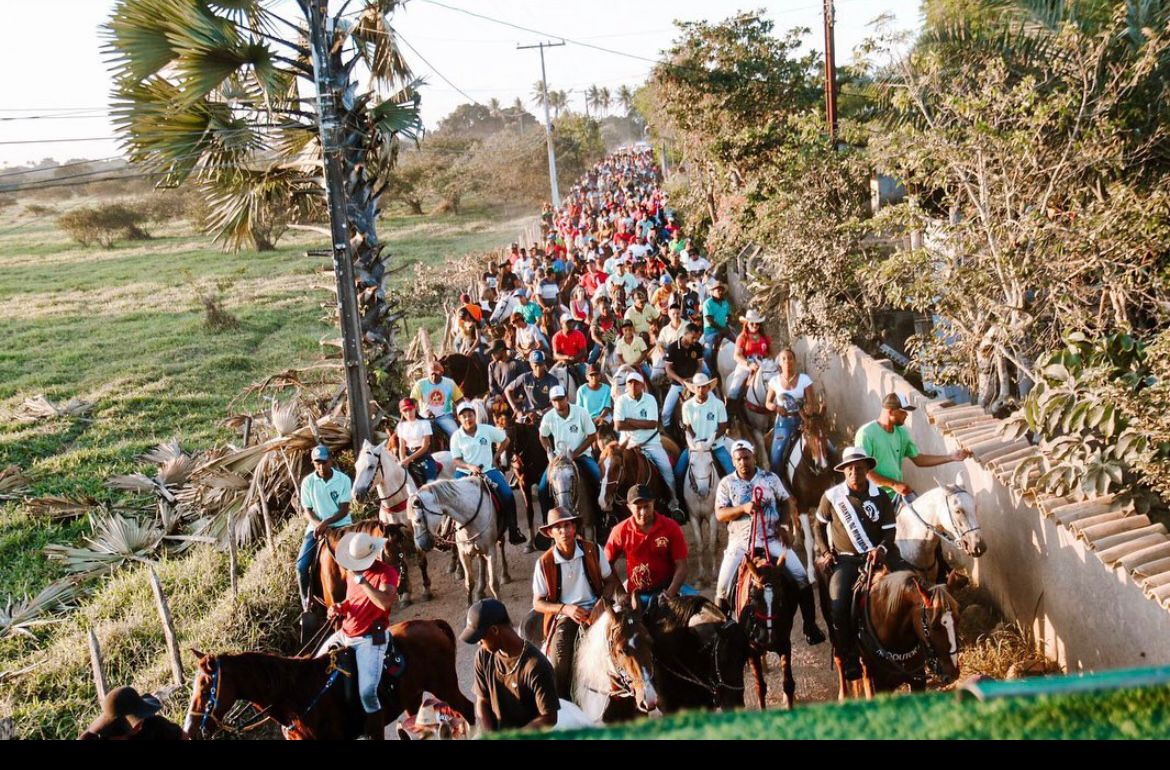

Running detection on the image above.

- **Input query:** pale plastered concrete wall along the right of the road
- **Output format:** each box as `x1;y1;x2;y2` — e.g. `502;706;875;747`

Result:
728;257;1170;672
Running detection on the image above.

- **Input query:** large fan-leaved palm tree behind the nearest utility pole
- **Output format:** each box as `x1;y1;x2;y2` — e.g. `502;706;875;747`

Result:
103;0;422;411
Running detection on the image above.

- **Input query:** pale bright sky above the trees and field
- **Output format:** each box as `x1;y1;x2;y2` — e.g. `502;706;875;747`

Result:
0;0;921;167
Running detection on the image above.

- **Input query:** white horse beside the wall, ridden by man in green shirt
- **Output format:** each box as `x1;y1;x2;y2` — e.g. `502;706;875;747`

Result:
896;483;987;586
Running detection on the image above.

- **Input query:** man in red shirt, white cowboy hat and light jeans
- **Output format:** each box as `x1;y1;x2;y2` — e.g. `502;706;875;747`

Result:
322;532;398;741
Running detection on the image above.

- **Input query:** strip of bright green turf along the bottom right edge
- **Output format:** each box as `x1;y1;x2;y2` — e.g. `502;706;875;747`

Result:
517;687;1170;741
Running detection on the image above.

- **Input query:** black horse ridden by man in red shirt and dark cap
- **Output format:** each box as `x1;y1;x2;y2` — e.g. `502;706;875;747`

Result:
644;594;751;714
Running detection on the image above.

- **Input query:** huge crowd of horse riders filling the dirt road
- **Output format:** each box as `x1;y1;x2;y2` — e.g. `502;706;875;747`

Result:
107;150;982;737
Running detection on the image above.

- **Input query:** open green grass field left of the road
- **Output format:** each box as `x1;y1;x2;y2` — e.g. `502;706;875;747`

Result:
0;197;521;594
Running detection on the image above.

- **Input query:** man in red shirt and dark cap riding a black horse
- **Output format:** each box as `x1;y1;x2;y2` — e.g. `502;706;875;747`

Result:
605;484;698;603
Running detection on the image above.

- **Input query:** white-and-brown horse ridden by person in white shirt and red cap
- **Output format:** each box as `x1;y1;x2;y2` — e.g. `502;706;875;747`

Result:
348;441;452;607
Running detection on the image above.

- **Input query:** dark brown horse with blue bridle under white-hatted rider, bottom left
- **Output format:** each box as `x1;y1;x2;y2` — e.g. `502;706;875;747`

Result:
184;620;475;741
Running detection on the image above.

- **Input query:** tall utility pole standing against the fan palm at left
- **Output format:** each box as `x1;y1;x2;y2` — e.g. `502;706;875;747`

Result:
297;0;372;452
